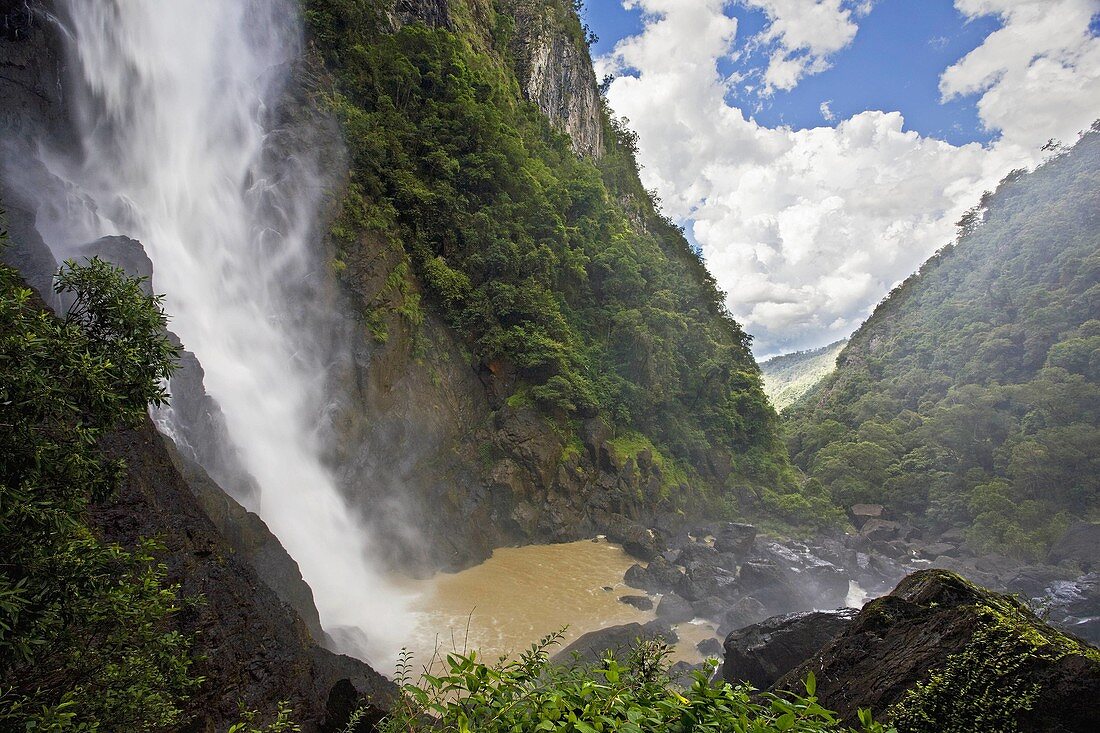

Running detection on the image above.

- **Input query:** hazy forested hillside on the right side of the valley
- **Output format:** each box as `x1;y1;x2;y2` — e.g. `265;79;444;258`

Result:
789;125;1100;558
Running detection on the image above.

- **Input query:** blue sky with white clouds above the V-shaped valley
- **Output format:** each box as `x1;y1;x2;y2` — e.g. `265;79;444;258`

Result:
582;0;1100;359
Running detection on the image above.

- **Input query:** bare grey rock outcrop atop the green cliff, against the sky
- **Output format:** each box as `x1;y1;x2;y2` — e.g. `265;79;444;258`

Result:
505;0;604;158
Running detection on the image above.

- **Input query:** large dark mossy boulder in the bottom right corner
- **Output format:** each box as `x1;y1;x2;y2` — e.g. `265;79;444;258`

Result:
774;570;1100;733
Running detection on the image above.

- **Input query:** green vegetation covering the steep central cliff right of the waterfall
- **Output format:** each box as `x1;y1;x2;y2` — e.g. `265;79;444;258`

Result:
306;0;796;512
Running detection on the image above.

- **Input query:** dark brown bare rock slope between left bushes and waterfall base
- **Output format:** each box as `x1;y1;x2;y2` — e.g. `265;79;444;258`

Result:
91;420;395;731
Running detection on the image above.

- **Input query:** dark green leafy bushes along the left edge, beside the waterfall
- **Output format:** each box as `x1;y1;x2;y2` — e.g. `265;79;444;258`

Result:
0;242;199;732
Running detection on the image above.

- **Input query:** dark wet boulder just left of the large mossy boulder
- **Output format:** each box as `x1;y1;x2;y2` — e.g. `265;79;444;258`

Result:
722;609;856;690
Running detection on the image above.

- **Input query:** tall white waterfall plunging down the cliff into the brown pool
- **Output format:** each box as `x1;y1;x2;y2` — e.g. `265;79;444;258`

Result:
39;0;409;663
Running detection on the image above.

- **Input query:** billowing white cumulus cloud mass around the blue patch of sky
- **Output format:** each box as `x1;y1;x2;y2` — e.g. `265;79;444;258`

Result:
600;0;1100;357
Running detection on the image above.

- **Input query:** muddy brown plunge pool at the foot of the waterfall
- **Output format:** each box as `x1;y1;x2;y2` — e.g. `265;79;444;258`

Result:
400;539;714;669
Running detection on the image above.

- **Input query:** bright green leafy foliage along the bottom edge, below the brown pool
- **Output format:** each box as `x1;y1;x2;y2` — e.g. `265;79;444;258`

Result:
382;634;886;733
